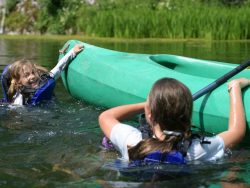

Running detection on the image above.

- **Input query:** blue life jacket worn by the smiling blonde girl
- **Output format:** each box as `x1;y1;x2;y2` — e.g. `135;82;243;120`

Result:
1;65;56;105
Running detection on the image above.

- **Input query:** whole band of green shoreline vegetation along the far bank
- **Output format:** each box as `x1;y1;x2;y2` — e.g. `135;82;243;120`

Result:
0;0;250;41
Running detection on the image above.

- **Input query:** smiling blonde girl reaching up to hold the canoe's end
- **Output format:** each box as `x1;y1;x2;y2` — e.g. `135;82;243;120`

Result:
2;44;83;105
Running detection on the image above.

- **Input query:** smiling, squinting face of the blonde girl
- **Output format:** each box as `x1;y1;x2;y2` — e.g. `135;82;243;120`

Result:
19;66;40;88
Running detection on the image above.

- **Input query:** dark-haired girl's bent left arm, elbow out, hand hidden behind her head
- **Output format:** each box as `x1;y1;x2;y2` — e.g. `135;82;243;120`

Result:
99;102;145;138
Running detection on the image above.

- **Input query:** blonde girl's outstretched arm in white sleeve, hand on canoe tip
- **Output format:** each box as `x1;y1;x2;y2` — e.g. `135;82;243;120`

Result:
49;44;83;79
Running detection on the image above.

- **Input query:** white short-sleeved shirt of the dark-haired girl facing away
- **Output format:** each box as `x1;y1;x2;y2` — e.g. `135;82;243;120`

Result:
110;123;225;161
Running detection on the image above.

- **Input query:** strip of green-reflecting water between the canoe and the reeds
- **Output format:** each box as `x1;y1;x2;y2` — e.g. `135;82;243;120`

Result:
91;41;250;64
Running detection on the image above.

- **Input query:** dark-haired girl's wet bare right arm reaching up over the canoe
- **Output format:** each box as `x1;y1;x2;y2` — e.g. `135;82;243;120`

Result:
218;78;250;148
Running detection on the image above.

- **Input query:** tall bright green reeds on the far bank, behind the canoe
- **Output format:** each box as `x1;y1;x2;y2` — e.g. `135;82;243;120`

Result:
76;4;250;40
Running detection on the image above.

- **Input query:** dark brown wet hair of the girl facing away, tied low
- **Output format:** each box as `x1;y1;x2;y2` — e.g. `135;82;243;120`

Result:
128;78;193;160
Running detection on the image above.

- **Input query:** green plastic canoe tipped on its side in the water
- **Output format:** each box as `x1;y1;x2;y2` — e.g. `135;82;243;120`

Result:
60;40;250;133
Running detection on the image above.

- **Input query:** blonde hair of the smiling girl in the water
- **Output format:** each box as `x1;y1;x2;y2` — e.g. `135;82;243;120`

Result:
7;59;48;102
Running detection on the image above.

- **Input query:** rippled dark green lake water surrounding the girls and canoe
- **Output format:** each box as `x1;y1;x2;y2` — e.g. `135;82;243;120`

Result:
0;39;250;187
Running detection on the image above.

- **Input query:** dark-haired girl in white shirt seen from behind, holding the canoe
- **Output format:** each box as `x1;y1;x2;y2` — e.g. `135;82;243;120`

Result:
99;78;250;161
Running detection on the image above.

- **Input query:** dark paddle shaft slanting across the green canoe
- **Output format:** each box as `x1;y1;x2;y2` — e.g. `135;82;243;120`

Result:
193;60;250;101
